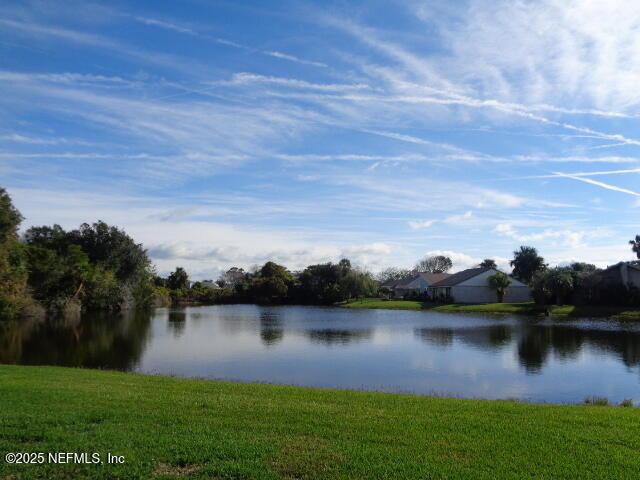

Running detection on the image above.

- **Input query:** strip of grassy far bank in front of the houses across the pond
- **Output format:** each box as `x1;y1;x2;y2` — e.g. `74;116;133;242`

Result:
340;298;640;320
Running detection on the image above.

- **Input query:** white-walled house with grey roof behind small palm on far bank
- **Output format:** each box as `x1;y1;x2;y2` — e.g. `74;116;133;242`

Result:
428;267;531;303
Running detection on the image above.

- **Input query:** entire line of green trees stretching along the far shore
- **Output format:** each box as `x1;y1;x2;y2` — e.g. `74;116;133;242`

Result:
0;188;640;318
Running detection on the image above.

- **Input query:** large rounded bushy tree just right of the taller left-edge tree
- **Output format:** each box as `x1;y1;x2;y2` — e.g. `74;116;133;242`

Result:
24;221;154;313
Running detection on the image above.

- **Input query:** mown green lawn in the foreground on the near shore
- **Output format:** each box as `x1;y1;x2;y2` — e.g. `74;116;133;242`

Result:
0;366;640;480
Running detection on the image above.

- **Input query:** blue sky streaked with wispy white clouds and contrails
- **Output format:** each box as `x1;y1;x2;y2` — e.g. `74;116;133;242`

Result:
0;0;640;279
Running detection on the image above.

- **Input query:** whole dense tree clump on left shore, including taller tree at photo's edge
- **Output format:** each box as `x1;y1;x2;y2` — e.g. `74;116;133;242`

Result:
0;188;155;318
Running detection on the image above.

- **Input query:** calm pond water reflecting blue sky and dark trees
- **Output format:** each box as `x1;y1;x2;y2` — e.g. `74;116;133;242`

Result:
0;305;640;403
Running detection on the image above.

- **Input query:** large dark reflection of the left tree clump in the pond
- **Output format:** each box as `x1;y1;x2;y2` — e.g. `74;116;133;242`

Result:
0;312;151;370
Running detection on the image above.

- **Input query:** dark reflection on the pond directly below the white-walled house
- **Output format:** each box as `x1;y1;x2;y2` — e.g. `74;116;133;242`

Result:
413;325;511;350
